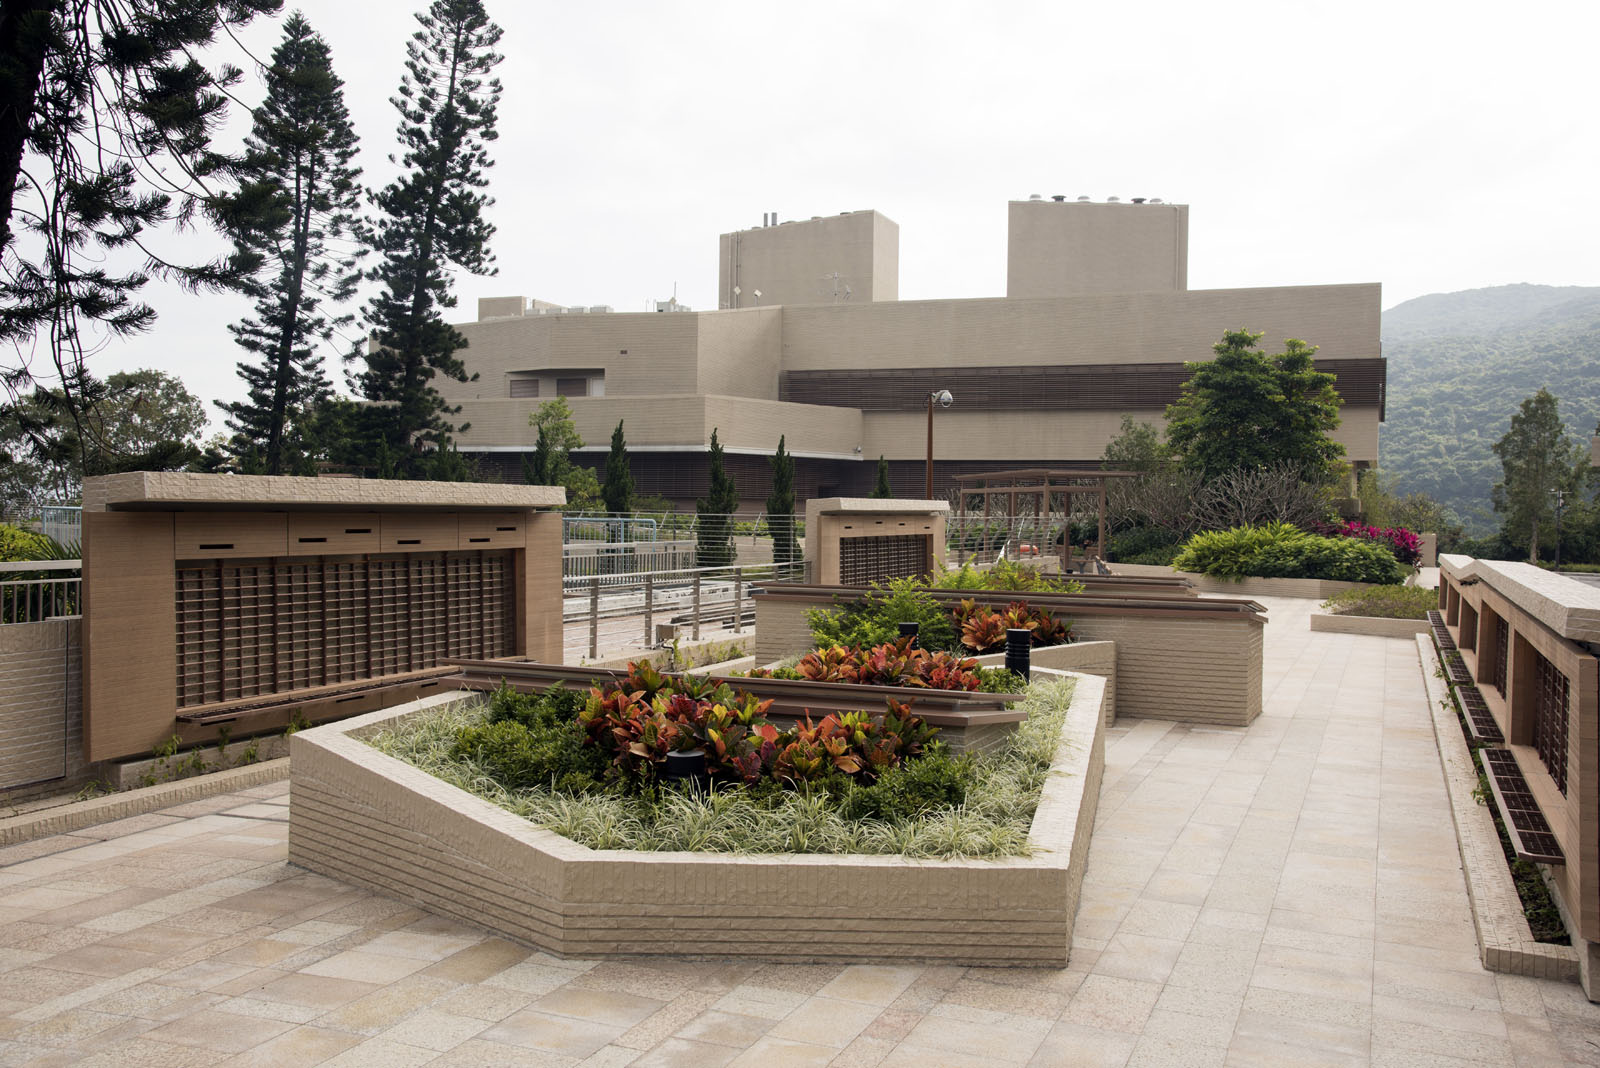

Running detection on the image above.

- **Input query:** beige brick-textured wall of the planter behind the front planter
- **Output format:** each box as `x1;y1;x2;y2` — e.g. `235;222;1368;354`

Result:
754;584;1264;727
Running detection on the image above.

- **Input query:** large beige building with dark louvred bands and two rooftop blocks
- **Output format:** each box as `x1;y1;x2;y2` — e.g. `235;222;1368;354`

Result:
438;200;1386;508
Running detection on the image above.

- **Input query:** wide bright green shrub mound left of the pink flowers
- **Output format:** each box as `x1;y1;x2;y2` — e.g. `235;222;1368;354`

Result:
1173;523;1408;585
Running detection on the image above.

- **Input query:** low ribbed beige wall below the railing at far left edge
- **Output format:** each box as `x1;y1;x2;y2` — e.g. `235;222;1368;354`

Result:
0;617;86;801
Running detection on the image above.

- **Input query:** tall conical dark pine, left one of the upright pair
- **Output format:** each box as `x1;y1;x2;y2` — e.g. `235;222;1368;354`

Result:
219;11;362;475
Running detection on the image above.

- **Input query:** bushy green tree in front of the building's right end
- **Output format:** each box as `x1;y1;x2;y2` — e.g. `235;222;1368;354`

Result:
1166;331;1344;483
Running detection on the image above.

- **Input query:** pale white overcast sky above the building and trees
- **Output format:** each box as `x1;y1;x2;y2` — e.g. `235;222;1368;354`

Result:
103;0;1600;431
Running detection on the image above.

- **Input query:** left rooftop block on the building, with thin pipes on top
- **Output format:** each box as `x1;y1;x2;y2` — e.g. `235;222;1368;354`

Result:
717;211;899;309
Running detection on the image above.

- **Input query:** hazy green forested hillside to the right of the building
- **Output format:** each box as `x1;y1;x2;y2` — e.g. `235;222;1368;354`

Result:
1379;285;1600;532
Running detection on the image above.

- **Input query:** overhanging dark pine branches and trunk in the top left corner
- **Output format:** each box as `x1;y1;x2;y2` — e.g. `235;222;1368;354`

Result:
0;0;280;468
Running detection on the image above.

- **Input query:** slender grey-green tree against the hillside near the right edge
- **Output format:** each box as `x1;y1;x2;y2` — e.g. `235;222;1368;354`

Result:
1491;389;1589;563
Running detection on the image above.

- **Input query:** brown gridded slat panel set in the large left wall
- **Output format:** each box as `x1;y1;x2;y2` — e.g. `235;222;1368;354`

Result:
174;550;515;708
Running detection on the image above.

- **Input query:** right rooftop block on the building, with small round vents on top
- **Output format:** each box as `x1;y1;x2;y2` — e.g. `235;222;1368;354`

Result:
1005;197;1189;297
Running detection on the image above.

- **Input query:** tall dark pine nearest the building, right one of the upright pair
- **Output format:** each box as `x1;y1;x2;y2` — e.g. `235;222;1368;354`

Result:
355;0;501;478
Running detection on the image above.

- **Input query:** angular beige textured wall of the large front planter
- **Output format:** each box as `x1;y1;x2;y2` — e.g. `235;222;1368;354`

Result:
290;676;1104;967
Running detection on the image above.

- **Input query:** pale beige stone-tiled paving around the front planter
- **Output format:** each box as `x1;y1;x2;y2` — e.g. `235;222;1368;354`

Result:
0;598;1600;1068
